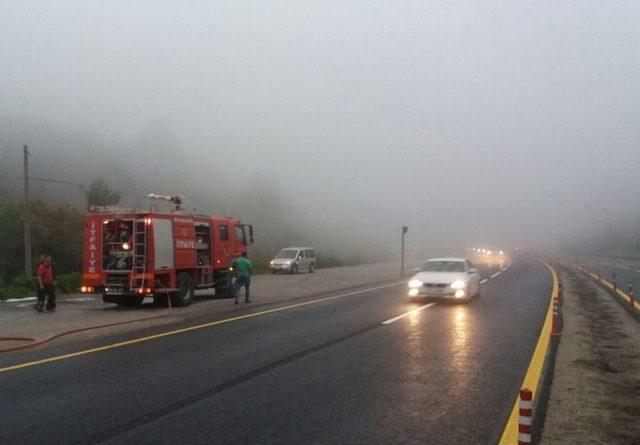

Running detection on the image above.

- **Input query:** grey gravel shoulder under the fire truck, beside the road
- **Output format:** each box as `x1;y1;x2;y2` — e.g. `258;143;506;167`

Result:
0;263;410;348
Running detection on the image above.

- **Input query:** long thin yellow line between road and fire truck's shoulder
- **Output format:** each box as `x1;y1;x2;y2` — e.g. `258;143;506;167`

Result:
0;281;404;373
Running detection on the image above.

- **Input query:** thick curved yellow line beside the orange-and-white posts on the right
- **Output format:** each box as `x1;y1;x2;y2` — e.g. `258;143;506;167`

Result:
499;262;558;445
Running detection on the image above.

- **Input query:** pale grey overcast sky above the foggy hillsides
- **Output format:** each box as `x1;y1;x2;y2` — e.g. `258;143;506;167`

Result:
0;0;640;253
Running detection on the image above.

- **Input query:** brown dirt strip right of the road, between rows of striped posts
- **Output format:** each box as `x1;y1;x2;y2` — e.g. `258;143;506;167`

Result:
542;269;640;444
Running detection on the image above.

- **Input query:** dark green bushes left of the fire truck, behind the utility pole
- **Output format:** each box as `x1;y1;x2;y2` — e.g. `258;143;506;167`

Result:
0;201;83;282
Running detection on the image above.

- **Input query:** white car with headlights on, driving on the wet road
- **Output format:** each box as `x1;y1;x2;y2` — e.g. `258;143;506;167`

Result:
409;258;480;300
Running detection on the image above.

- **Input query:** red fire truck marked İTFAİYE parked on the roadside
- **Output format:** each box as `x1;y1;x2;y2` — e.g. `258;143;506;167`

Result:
81;195;253;306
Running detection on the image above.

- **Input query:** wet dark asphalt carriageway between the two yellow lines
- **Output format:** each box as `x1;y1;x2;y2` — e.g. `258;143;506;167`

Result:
0;259;552;444
